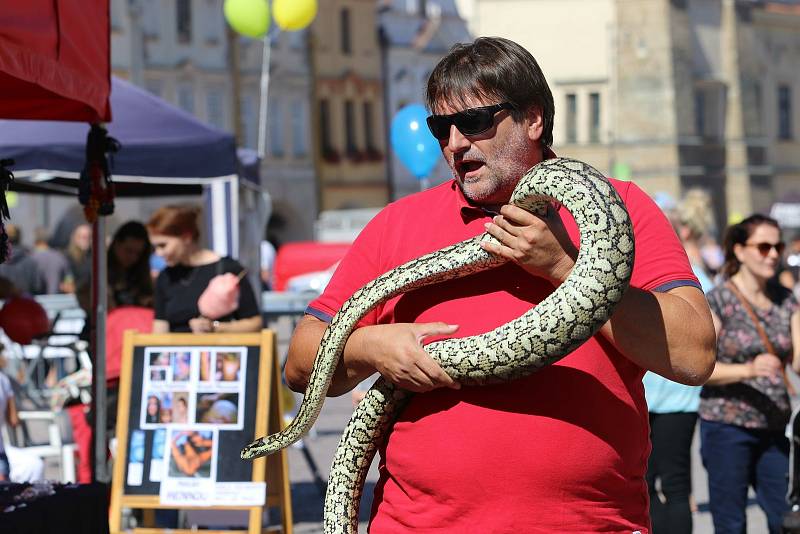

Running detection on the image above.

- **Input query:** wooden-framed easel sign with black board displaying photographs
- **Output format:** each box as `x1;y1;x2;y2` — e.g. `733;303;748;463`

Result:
110;330;292;534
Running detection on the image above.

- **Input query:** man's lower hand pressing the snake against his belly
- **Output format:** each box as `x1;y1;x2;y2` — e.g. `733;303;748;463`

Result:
353;323;461;393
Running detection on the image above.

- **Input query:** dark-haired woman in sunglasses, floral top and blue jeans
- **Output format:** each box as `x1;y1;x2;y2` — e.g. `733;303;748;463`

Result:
699;215;800;533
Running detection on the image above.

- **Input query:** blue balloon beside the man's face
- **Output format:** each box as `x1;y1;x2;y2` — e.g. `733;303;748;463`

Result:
390;104;442;180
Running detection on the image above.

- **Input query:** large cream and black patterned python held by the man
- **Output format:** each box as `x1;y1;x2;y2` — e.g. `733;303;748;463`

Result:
241;158;634;533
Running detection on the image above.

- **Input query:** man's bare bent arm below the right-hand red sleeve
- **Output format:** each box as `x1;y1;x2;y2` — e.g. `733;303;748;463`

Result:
600;286;715;385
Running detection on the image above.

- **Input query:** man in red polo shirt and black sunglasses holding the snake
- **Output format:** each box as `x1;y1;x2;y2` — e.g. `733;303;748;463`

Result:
286;38;714;534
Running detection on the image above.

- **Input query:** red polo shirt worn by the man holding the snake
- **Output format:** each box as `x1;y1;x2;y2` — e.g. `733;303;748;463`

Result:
308;175;699;534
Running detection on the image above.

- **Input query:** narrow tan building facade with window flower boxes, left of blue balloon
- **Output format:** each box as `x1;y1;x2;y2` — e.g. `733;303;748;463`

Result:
311;0;389;214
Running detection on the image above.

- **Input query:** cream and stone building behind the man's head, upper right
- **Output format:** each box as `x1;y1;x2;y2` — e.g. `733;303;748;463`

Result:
461;0;800;233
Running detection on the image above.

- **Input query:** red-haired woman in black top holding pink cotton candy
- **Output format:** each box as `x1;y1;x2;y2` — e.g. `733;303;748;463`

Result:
147;206;262;333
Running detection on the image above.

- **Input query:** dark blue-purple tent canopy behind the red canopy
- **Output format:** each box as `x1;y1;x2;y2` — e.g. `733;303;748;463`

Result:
0;78;238;196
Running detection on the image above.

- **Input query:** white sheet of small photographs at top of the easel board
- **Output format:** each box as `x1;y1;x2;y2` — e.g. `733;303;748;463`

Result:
139;347;247;430
